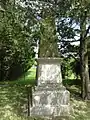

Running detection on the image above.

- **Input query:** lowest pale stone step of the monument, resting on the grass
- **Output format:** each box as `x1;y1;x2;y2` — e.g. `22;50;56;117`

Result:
31;105;70;116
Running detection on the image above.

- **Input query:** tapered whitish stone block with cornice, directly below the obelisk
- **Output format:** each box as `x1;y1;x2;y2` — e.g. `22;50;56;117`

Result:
37;58;62;85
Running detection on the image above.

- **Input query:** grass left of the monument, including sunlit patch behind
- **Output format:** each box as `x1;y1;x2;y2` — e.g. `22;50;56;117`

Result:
0;69;36;120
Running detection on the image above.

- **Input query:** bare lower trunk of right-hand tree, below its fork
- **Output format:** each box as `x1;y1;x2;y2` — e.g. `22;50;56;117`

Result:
80;37;89;99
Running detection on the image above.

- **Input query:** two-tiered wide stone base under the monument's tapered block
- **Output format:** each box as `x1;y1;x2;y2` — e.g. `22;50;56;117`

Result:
30;87;70;117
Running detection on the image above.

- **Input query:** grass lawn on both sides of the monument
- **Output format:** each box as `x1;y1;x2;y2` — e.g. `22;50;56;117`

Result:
0;68;90;120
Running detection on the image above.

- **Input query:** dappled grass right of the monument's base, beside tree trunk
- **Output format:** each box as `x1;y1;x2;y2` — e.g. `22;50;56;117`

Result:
63;79;90;120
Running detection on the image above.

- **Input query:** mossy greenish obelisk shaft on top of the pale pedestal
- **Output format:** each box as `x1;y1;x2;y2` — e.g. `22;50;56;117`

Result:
39;17;58;58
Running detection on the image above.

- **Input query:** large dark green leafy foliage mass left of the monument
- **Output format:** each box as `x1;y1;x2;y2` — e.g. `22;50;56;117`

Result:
0;1;35;80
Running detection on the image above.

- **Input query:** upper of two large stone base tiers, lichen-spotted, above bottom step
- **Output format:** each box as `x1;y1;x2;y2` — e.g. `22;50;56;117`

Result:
33;90;70;106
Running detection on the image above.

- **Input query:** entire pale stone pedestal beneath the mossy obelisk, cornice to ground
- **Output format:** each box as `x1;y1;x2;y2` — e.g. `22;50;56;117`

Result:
30;58;70;117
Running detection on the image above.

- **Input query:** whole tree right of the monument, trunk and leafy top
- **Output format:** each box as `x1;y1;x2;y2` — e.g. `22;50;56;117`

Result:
68;0;90;99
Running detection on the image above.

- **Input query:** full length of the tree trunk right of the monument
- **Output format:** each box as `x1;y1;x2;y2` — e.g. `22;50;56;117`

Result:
80;13;89;99
